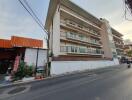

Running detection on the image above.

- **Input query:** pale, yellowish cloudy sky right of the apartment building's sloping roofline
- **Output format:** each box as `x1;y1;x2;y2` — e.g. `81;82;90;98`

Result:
72;0;132;40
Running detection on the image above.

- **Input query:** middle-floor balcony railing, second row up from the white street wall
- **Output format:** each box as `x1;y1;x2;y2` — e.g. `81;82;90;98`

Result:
66;33;101;45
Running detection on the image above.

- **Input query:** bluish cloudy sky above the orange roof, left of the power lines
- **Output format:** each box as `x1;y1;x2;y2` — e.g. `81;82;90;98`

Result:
0;0;44;39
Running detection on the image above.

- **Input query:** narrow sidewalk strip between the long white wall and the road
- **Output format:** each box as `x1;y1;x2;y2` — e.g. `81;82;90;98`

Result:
0;64;126;89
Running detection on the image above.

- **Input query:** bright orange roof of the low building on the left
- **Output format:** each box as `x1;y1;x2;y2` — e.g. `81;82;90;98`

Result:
0;36;43;48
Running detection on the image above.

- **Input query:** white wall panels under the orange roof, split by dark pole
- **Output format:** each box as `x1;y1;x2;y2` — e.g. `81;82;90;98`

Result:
24;48;47;66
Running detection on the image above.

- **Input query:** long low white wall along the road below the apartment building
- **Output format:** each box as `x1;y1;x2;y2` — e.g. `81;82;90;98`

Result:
51;59;119;75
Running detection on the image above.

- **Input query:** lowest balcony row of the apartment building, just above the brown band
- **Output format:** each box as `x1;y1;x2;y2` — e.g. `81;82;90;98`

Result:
60;46;104;55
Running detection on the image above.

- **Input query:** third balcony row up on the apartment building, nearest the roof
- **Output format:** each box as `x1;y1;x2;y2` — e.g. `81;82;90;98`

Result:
61;20;100;38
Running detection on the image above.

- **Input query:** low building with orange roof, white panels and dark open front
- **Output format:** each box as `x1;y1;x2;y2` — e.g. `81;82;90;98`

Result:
0;36;47;74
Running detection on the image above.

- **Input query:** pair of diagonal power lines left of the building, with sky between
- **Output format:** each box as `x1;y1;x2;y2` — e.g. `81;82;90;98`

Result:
18;0;48;39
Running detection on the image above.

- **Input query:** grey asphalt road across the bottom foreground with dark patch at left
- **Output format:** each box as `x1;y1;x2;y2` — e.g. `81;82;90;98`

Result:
0;67;132;100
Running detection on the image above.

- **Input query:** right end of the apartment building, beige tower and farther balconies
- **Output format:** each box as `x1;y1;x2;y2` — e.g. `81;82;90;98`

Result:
100;18;124;58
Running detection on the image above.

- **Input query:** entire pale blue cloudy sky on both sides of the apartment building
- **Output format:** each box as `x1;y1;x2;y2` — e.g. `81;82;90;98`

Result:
0;0;132;44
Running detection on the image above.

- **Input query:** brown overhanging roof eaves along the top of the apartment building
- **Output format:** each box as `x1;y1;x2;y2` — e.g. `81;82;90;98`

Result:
45;0;102;30
